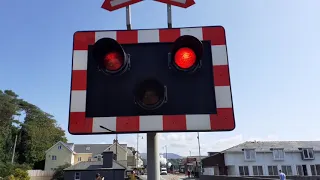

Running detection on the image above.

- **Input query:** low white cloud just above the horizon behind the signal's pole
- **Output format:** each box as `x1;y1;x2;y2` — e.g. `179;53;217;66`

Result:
115;133;279;156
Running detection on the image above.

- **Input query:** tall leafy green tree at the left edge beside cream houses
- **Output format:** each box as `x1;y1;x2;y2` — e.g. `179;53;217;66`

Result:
0;90;67;168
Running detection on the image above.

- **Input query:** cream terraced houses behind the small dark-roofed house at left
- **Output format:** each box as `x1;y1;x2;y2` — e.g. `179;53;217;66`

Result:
45;140;143;171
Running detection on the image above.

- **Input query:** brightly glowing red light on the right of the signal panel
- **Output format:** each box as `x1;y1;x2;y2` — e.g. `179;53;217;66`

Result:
174;47;197;69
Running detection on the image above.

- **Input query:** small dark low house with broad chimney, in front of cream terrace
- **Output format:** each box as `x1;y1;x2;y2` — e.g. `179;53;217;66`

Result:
64;151;126;180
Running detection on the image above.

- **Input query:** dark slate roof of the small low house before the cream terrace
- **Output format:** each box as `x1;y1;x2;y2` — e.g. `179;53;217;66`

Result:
64;161;126;171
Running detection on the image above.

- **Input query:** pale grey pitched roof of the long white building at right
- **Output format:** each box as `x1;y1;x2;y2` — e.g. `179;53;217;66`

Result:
222;141;320;152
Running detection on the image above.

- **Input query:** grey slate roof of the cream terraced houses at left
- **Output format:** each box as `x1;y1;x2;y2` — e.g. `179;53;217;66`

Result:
74;144;127;155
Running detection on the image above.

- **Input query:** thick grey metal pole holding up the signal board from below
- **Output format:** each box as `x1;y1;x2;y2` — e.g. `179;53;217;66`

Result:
147;133;160;180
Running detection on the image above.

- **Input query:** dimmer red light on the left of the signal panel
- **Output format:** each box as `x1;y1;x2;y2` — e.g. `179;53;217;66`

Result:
104;52;124;71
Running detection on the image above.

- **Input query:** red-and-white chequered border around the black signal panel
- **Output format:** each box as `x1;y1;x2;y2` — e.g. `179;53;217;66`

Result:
69;26;235;134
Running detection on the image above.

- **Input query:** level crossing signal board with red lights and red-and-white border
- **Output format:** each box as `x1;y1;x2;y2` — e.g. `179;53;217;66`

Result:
69;26;235;134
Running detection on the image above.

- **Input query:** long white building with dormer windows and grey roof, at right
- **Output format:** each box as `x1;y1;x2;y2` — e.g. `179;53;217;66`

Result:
202;141;320;176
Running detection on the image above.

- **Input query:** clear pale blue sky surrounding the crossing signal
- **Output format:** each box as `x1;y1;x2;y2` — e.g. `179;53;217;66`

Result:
0;0;320;154
